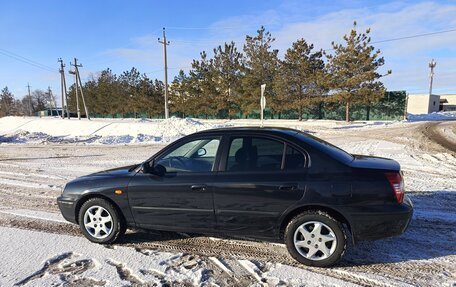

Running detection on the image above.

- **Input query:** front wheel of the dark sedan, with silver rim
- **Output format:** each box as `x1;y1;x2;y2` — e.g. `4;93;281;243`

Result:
78;198;126;244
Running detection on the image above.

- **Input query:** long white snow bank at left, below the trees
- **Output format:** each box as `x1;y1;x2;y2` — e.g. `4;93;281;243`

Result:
0;117;223;144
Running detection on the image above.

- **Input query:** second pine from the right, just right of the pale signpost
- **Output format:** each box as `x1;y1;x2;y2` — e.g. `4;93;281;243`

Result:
274;39;325;120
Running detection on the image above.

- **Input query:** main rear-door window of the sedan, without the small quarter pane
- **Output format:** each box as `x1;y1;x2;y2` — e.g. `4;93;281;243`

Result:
226;137;284;171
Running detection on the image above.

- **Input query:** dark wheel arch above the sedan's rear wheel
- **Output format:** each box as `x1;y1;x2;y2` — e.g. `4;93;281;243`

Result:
279;204;354;243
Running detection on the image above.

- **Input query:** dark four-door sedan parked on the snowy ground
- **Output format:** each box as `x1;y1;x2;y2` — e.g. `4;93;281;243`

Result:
57;128;413;266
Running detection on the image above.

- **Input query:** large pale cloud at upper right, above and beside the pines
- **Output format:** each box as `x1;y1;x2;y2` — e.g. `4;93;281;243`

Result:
274;2;456;92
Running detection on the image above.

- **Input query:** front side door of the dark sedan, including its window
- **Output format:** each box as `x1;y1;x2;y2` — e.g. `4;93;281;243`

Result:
128;136;220;233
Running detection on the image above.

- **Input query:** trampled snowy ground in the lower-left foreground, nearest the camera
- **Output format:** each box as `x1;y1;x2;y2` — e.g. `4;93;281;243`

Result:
0;227;362;286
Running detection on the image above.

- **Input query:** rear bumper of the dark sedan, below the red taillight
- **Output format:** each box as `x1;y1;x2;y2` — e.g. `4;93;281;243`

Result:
351;196;413;241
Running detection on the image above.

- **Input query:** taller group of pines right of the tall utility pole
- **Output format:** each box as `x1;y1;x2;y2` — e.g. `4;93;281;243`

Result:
170;22;391;121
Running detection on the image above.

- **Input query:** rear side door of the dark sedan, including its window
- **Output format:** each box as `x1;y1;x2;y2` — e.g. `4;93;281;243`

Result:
214;136;306;240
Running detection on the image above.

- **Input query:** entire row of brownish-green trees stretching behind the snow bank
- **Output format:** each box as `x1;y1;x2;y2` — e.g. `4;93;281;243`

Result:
0;22;391;120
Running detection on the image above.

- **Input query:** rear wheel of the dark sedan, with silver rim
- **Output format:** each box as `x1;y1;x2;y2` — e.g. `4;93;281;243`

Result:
284;211;347;267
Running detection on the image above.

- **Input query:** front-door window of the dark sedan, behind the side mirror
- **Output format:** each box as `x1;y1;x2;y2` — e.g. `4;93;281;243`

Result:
155;137;220;173
